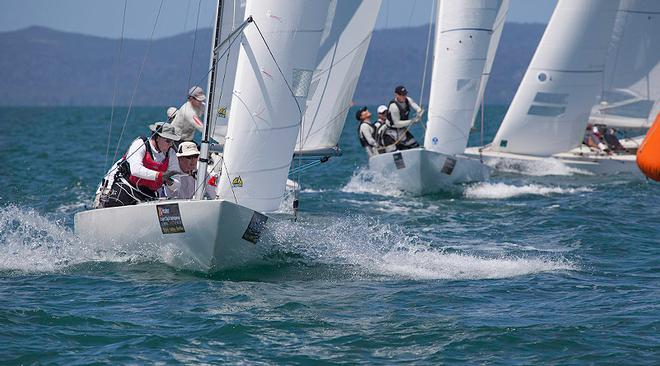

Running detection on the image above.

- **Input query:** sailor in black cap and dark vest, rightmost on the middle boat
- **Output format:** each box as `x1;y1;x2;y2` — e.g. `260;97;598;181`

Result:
387;85;424;150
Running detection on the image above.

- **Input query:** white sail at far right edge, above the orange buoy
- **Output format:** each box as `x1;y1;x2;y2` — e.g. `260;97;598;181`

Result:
590;0;660;128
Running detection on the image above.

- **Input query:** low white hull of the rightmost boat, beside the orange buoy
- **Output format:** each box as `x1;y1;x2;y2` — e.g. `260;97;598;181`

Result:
465;147;643;178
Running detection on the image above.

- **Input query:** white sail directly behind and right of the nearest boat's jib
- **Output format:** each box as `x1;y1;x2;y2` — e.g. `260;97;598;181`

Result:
296;0;381;152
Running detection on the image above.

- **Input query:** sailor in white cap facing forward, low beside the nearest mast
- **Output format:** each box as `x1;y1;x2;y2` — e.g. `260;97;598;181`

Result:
162;141;217;199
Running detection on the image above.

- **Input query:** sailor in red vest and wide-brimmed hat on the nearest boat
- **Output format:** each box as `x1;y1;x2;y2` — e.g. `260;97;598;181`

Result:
99;122;180;207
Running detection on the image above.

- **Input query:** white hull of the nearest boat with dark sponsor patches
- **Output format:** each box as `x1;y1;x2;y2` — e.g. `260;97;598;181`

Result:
74;200;266;272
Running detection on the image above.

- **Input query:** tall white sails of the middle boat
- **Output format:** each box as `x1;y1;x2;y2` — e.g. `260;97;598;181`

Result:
424;0;508;154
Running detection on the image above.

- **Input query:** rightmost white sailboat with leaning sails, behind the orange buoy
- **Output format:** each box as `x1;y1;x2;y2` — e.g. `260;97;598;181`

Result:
465;0;660;176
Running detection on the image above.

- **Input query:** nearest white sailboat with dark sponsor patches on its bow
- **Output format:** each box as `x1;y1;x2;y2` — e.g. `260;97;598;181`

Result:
74;0;329;272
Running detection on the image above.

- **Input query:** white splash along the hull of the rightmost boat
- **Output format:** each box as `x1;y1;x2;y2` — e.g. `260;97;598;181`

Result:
486;158;593;177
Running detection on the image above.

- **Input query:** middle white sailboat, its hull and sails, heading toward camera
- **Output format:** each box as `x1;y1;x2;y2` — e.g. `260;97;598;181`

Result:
369;0;508;194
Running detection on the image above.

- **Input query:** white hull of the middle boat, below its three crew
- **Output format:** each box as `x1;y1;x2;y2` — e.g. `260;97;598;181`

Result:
369;147;490;194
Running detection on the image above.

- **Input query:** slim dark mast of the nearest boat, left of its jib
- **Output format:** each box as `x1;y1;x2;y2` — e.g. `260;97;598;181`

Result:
195;0;222;200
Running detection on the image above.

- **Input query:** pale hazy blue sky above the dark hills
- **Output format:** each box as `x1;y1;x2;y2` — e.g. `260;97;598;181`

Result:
0;0;556;38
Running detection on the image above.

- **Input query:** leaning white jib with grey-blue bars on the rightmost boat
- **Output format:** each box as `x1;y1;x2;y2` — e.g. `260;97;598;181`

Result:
492;0;619;156
